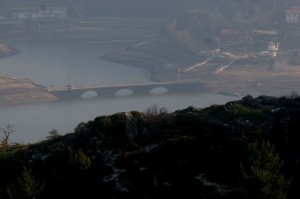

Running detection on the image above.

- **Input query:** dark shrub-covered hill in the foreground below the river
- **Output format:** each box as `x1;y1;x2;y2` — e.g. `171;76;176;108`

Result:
0;96;300;199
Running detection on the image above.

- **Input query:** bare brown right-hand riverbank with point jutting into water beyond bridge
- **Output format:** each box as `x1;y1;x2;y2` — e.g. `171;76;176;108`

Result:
101;44;300;96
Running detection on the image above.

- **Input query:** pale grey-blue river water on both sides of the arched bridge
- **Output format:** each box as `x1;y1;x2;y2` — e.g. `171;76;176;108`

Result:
0;41;239;143
